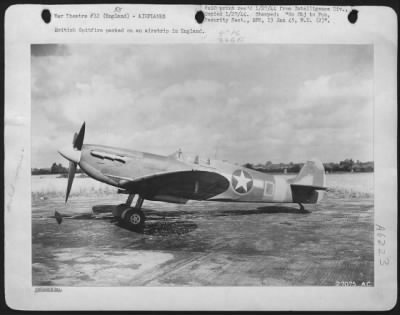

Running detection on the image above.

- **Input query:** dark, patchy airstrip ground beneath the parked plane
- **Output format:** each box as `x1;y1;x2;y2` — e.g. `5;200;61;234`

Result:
32;188;374;286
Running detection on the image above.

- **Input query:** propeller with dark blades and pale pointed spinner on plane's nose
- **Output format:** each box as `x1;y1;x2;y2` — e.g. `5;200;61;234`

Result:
58;123;85;203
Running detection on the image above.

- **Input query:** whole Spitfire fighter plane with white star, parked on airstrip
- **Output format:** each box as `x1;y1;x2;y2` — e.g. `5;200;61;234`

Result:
59;123;326;229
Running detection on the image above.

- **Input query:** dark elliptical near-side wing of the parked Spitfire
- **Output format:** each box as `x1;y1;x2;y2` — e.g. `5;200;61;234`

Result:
115;170;230;202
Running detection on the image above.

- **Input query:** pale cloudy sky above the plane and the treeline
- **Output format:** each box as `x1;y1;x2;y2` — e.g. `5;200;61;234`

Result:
31;44;373;167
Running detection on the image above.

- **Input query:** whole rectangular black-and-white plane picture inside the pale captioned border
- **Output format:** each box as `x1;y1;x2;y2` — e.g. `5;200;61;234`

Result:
31;44;374;286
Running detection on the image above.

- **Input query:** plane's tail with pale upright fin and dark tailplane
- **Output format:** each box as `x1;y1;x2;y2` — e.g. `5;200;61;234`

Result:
289;159;326;203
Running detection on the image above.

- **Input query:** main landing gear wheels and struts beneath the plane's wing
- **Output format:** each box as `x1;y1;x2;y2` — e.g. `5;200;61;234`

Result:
113;194;146;230
